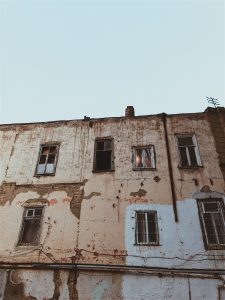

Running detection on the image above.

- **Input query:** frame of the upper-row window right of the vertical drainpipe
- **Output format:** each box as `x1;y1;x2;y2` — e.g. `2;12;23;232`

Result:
175;133;202;169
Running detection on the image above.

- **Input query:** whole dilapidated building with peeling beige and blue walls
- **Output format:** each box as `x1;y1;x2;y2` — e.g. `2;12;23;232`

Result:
0;107;225;300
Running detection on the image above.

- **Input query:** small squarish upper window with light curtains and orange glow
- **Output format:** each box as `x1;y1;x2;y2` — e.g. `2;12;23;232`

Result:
132;145;155;170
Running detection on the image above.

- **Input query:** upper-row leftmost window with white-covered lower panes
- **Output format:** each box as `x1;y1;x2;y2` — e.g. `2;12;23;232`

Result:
36;145;59;175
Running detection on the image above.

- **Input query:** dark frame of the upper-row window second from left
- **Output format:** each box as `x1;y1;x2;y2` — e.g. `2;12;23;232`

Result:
92;136;115;173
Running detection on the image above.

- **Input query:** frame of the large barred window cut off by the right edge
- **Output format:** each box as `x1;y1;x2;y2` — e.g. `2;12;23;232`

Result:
197;198;225;250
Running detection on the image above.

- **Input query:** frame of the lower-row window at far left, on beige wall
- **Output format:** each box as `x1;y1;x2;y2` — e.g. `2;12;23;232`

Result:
17;205;44;246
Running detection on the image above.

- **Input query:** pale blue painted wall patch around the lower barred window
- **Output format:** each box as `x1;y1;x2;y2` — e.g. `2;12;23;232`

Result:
125;197;225;270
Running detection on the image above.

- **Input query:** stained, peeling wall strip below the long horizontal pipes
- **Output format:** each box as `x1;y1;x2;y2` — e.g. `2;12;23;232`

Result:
0;269;225;300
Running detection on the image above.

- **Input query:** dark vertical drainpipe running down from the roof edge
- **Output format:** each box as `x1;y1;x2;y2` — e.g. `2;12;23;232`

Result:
161;113;178;222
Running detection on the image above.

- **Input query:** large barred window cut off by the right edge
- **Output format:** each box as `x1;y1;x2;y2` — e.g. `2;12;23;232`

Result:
198;199;225;249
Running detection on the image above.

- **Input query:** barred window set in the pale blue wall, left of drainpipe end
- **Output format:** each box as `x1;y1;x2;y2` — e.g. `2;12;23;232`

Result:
135;211;159;245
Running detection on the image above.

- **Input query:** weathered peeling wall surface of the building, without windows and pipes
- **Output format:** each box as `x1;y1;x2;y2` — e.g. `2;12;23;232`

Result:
0;109;225;300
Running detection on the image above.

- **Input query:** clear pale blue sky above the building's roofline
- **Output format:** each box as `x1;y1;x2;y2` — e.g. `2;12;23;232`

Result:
0;0;225;123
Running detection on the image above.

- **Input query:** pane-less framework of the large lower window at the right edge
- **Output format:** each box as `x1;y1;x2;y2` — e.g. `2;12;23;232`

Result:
198;198;225;249
